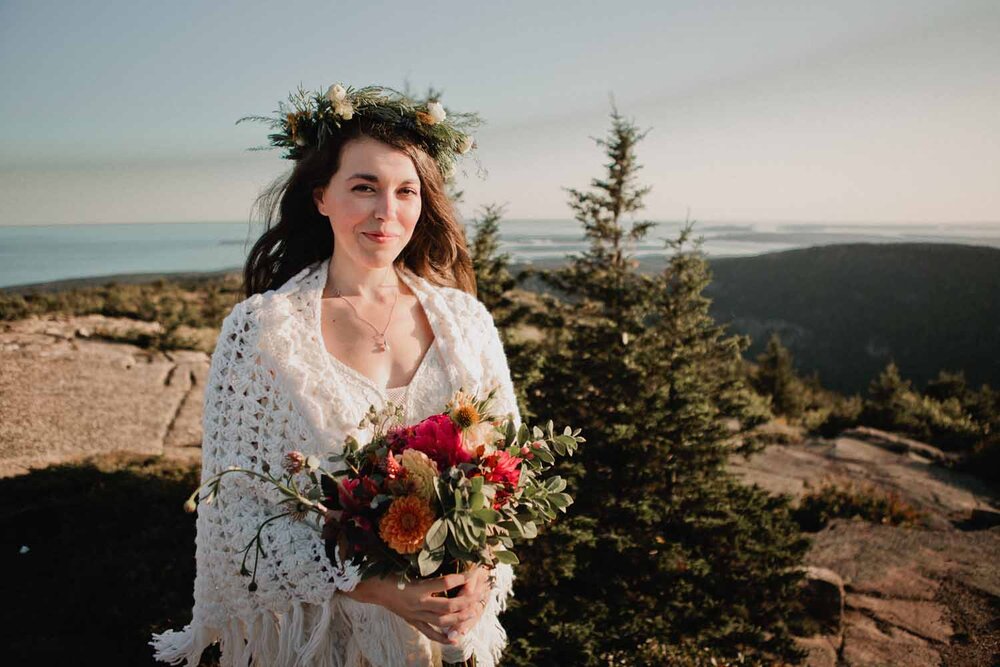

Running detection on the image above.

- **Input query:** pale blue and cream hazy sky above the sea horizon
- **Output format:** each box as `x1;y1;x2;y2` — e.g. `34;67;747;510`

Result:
0;0;1000;225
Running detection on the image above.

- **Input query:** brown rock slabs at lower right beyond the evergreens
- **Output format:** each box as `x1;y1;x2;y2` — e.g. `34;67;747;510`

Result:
731;429;1000;667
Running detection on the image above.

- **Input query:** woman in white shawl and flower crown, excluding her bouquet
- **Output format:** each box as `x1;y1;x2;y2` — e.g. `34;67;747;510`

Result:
151;85;520;667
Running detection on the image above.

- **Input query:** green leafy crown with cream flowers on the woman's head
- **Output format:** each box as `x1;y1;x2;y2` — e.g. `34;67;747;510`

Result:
236;83;482;178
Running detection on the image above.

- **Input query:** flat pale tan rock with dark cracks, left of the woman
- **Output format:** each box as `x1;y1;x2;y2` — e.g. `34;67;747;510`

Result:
0;315;209;477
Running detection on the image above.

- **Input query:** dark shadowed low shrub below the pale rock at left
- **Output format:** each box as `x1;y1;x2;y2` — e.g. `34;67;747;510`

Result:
0;455;218;667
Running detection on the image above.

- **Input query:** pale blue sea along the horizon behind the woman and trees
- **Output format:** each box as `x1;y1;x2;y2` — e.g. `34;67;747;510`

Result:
0;220;1000;287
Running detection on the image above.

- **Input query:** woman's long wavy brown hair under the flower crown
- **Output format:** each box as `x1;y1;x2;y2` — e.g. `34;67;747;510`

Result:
243;121;476;297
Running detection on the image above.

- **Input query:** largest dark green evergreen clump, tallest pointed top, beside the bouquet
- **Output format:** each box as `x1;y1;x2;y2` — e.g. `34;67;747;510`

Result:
505;108;808;665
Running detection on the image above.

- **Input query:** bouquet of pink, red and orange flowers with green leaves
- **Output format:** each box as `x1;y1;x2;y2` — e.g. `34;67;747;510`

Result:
185;390;585;664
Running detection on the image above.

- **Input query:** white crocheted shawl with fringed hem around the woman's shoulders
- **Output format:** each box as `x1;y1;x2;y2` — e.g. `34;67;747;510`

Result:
150;259;521;667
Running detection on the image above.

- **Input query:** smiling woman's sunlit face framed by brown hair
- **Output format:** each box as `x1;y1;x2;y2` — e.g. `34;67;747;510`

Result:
313;137;421;269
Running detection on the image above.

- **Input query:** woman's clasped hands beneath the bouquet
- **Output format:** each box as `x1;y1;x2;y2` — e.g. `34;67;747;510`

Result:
343;567;489;645
